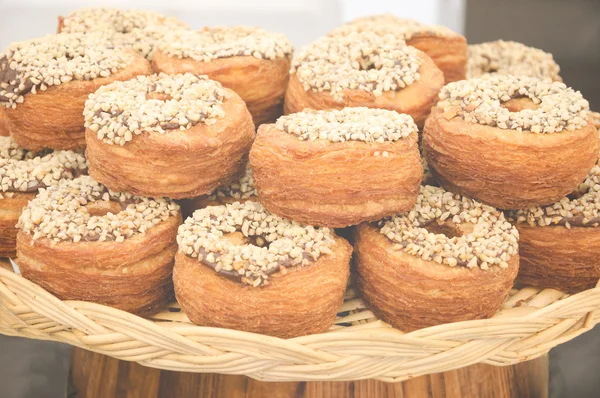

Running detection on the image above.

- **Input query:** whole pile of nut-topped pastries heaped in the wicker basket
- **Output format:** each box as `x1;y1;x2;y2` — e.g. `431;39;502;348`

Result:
0;8;600;338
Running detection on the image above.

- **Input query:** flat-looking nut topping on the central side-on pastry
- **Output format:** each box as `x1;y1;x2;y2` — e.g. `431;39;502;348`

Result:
275;107;418;143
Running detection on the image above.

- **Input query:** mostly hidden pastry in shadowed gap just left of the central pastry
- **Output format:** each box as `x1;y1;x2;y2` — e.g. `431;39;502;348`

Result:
179;163;258;218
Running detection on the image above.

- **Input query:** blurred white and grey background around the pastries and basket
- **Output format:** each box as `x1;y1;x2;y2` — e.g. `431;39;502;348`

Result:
0;0;600;398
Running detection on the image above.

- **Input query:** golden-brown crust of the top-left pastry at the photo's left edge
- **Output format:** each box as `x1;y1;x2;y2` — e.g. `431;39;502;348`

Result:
4;54;152;151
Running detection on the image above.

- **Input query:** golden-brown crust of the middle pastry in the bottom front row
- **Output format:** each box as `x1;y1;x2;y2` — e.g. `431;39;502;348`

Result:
173;237;352;338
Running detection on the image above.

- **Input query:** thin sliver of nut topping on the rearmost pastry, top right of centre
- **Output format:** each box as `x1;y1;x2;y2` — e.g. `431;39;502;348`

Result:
330;14;459;41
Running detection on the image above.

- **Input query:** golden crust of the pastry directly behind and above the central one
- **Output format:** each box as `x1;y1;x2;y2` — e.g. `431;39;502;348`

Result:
284;52;444;127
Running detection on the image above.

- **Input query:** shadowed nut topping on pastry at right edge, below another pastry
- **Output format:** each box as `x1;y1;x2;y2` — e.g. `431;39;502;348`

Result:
506;165;600;228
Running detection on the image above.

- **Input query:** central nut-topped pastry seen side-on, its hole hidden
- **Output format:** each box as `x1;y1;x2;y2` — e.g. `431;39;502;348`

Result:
250;108;423;228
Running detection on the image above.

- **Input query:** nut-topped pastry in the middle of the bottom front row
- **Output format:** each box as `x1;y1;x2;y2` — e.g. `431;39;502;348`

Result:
173;202;352;338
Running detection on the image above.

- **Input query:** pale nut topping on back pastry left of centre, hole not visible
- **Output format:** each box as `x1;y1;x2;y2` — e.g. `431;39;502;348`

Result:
156;26;294;62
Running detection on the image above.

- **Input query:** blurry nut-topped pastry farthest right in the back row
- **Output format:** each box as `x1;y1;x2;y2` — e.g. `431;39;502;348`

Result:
467;40;562;81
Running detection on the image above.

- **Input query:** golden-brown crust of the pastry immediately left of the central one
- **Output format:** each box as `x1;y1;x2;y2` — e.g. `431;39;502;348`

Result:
86;89;254;199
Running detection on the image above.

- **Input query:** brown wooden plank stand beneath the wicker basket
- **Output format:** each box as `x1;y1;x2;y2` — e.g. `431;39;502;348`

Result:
71;348;548;398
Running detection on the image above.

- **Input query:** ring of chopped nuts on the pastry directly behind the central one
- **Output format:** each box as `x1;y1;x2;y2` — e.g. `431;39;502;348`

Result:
290;32;422;101
